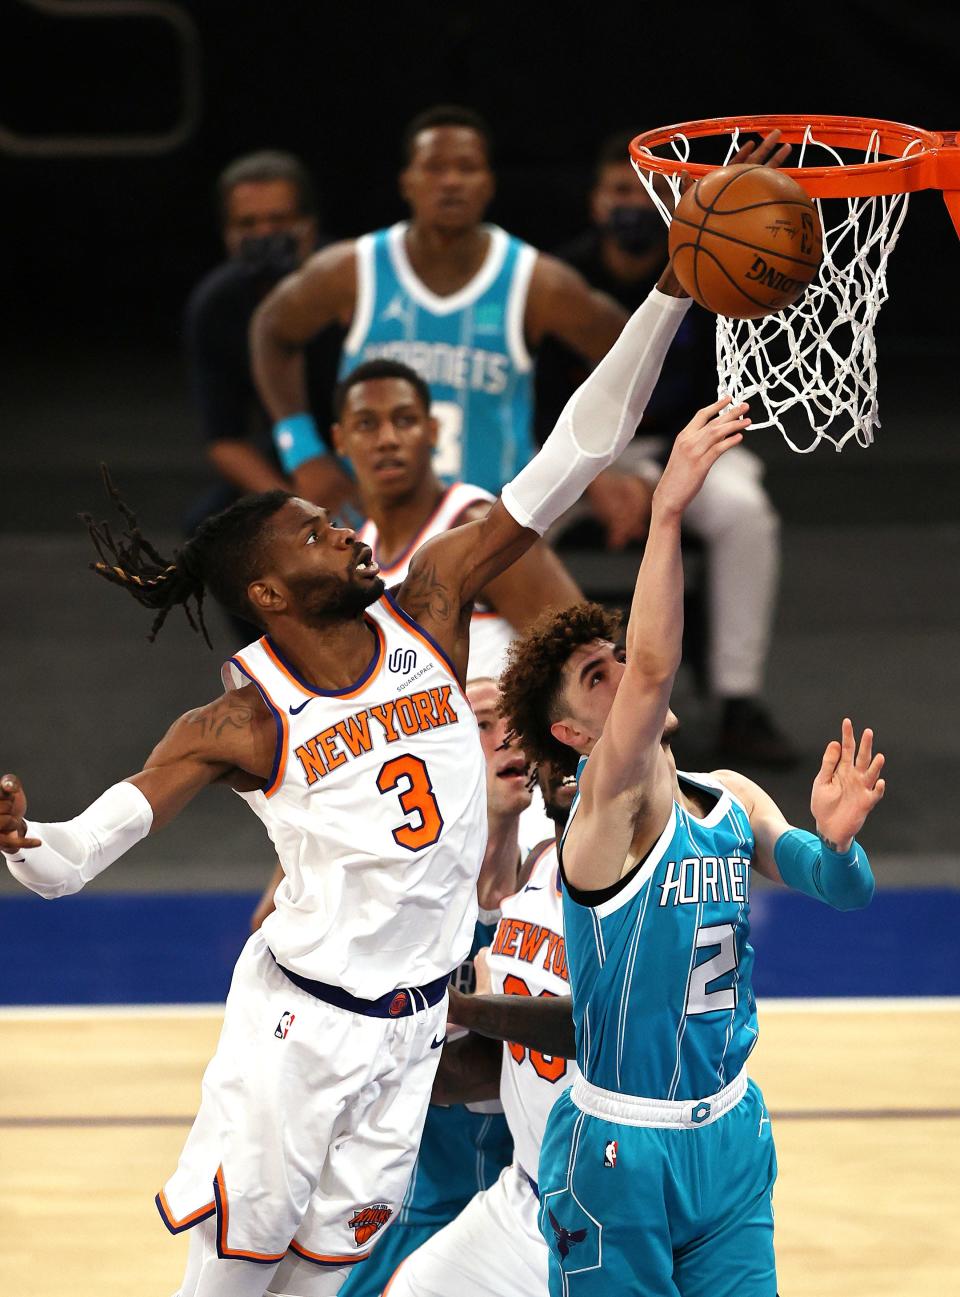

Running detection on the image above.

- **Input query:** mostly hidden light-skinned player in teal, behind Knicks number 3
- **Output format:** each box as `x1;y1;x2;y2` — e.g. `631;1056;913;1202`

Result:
340;680;531;1297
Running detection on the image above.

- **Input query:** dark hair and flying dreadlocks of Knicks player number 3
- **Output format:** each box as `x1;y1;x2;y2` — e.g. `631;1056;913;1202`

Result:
80;464;292;649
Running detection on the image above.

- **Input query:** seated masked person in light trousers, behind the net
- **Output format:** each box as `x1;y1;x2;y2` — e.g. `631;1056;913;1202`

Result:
537;132;798;767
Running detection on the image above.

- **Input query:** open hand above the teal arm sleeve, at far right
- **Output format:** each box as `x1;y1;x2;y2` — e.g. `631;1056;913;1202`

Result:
810;717;886;852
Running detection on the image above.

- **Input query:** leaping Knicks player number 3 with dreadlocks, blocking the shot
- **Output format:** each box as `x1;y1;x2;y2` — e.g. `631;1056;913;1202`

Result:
0;245;690;1297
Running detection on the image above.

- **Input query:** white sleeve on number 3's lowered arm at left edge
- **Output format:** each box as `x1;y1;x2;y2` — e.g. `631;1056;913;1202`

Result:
6;783;153;900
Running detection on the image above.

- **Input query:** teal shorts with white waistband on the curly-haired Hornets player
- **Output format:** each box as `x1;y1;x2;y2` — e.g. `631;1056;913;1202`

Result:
538;1082;777;1297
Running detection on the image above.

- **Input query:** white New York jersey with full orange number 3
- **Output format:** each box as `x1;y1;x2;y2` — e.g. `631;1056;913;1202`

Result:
223;594;486;1000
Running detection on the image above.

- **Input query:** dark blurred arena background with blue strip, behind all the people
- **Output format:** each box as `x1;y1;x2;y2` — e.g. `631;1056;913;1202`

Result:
0;0;960;1004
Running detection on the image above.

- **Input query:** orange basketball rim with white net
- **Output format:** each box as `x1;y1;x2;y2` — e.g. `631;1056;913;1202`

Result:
630;115;960;453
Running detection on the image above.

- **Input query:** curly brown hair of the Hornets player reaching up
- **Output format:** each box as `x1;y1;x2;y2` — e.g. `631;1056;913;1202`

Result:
499;603;623;774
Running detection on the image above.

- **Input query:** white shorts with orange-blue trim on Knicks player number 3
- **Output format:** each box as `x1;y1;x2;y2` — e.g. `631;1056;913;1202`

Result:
157;933;446;1266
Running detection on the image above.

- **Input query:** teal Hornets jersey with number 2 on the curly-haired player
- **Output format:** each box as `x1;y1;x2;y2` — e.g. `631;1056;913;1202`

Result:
563;763;756;1101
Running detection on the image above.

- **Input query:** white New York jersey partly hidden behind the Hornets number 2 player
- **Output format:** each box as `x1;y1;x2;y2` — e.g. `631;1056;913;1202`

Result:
489;840;580;1179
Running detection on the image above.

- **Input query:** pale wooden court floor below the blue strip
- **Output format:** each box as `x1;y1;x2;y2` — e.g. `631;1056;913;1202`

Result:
0;1000;960;1297
